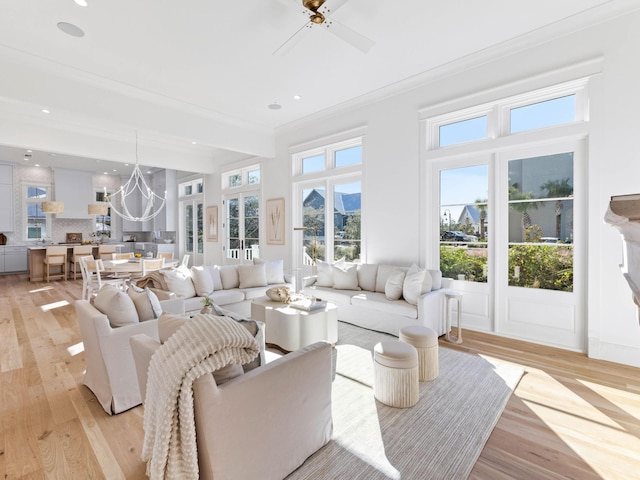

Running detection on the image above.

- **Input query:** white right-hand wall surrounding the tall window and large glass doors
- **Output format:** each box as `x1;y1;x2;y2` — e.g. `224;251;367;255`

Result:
256;13;640;366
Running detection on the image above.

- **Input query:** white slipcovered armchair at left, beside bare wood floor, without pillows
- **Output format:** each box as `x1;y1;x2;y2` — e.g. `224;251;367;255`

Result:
75;299;184;415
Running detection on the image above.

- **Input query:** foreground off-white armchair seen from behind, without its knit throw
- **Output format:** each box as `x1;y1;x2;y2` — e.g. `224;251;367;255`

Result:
131;335;333;480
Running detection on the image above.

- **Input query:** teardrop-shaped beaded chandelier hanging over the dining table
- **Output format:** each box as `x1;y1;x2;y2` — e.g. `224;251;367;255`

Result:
106;131;167;222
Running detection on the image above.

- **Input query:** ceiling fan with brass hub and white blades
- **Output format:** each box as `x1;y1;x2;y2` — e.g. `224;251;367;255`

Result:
273;0;375;55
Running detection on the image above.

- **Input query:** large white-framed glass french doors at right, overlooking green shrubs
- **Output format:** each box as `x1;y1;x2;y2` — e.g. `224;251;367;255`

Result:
433;141;586;351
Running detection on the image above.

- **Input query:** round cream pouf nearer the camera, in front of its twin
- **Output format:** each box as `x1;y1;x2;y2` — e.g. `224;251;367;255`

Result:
373;342;420;408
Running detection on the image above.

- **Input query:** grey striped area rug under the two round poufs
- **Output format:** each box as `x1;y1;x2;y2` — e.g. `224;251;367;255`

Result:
287;322;523;480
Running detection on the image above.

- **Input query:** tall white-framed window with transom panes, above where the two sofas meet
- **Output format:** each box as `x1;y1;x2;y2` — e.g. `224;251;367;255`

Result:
293;137;363;266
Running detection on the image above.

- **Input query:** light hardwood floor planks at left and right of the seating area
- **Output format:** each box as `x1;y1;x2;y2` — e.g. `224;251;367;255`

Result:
0;275;640;480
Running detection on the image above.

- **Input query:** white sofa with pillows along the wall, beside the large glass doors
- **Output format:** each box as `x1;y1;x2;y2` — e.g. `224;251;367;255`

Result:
303;261;446;336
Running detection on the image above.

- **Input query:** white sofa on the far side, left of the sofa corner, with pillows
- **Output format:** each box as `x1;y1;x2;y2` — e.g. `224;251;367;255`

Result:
137;259;295;317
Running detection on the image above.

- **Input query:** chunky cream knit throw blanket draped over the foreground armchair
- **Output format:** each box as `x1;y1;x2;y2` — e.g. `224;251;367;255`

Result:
142;315;259;480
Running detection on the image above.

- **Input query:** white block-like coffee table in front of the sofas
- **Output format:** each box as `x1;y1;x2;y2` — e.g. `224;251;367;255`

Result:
251;297;338;352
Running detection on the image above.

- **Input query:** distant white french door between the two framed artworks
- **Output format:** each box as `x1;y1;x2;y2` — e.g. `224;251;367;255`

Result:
224;191;260;264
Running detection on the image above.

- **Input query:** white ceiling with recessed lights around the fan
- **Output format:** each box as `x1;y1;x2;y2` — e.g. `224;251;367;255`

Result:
0;0;638;173
